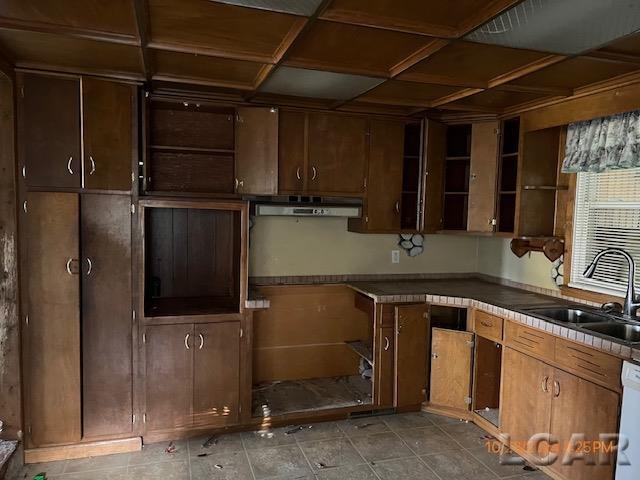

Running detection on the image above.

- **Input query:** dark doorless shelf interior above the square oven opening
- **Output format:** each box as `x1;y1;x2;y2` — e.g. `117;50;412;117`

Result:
144;98;235;194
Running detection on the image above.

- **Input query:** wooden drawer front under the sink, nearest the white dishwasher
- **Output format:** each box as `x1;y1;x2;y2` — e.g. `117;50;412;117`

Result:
555;338;622;389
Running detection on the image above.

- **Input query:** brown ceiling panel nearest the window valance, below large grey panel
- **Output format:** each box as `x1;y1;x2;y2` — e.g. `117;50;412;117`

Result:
511;57;640;88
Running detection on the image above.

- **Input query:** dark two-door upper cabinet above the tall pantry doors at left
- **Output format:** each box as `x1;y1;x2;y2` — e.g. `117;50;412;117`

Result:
17;73;137;191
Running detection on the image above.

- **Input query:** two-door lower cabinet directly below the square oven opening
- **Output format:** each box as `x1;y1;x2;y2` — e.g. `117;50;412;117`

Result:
143;322;240;431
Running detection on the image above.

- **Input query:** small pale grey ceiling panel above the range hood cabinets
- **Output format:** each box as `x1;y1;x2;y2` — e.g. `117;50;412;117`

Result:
260;67;384;100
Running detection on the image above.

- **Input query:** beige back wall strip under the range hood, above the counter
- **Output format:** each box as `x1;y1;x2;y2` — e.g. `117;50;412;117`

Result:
249;217;478;276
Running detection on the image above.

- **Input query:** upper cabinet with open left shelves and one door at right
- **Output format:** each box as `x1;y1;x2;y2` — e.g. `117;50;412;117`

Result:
143;97;278;196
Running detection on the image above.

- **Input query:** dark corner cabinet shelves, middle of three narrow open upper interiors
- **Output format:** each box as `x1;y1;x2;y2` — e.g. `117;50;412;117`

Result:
442;125;471;230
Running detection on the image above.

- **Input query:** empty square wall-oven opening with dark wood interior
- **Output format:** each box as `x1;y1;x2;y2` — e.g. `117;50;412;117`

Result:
141;200;247;317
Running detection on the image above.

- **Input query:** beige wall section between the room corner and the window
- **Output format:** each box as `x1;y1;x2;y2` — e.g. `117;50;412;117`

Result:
478;237;557;289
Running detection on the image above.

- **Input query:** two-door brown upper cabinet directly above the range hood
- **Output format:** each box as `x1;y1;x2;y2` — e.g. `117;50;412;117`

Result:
279;111;369;197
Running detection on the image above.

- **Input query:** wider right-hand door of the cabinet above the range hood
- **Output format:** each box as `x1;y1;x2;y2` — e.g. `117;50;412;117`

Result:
307;113;368;195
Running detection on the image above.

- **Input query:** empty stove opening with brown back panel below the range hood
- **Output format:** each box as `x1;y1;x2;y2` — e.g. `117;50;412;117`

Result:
252;285;370;417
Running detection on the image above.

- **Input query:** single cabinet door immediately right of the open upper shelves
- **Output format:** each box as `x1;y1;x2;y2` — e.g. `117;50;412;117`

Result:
235;107;278;195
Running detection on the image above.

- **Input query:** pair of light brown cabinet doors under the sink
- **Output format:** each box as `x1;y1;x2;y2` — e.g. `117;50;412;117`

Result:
501;348;620;480
